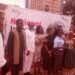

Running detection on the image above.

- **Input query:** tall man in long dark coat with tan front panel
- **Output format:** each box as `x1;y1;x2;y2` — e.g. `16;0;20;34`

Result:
7;19;25;75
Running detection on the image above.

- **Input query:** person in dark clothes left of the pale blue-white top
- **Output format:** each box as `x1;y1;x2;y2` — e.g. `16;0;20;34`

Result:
41;27;54;75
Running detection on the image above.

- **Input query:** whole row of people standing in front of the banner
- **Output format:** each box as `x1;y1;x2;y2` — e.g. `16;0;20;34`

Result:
0;19;75;75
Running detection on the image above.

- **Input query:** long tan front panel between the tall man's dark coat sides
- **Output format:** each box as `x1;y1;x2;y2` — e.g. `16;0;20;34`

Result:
13;29;20;64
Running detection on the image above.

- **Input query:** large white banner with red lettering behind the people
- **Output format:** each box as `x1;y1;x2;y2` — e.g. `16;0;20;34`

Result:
5;5;71;41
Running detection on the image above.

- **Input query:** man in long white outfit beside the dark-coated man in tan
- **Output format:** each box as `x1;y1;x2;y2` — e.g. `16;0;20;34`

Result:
23;25;35;75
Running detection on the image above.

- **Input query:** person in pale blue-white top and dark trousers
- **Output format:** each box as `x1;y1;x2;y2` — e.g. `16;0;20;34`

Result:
53;30;64;75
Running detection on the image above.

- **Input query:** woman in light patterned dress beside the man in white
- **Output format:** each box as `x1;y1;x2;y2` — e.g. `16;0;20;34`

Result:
34;26;45;74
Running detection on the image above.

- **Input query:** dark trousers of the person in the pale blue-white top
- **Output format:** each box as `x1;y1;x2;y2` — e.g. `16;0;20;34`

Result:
53;50;64;75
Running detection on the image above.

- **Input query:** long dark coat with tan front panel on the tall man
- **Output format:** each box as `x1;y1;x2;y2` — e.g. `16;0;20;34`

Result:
7;29;25;67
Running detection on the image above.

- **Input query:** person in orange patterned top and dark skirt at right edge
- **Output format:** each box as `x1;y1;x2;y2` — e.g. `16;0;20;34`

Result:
64;31;75;70
